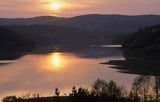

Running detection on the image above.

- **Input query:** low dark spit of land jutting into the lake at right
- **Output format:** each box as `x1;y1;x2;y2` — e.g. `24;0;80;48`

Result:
102;60;160;76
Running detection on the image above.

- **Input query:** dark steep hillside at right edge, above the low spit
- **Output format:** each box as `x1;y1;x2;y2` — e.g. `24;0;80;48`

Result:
123;25;160;61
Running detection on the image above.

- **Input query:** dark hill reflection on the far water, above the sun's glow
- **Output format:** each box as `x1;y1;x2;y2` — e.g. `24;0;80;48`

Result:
34;41;122;58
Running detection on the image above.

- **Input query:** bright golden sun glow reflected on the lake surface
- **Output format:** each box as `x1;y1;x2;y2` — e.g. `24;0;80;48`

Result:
41;52;76;72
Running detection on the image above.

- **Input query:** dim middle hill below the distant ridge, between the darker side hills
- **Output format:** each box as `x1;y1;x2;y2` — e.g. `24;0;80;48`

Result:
5;25;107;46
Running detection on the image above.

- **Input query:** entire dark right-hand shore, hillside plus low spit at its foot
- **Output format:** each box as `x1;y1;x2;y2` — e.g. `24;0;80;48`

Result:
102;25;160;75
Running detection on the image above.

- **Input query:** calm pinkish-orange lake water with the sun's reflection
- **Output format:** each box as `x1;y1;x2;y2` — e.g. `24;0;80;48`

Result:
0;48;138;98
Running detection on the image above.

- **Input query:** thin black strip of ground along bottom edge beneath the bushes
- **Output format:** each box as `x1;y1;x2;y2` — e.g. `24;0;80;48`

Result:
2;96;135;102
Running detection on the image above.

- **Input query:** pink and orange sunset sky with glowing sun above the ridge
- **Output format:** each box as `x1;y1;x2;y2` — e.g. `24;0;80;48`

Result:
0;0;160;18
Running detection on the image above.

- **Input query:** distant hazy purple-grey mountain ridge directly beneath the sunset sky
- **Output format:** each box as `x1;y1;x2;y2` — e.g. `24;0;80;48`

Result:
0;14;160;34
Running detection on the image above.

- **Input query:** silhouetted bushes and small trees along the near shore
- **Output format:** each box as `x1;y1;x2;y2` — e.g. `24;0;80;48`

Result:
2;76;160;102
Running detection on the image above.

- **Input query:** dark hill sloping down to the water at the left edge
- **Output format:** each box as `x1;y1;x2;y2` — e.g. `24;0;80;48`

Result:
0;27;34;60
